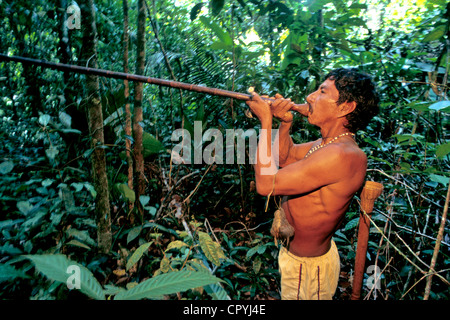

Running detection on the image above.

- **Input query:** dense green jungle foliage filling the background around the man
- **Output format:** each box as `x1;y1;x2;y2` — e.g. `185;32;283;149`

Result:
0;0;450;300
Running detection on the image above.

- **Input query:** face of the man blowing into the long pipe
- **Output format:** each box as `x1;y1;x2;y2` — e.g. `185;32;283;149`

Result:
306;79;339;127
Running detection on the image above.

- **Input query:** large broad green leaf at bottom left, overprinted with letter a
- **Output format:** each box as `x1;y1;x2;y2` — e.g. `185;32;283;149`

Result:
25;254;105;300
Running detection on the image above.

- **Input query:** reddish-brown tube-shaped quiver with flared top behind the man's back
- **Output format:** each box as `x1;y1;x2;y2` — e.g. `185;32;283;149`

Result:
351;181;383;300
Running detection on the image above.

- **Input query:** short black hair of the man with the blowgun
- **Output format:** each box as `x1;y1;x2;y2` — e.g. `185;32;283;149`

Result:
325;68;380;133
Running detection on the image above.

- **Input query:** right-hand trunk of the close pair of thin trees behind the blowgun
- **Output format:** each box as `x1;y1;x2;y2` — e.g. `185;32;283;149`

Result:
133;0;147;221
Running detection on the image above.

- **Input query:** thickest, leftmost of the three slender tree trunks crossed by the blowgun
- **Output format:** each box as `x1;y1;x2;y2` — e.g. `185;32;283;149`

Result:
80;0;112;253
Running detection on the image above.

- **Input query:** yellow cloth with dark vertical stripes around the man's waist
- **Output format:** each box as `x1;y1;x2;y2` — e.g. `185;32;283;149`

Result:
278;240;340;300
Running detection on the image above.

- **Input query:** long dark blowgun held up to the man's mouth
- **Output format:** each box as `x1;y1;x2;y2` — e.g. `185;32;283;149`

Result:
0;54;308;115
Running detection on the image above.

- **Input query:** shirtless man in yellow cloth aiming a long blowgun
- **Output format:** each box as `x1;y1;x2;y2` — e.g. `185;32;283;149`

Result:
247;69;379;300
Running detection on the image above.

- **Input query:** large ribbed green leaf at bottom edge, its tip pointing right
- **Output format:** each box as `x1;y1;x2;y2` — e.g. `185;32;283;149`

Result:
114;270;221;300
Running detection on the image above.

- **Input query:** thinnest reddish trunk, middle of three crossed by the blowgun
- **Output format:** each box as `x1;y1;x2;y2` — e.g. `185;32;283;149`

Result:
123;0;134;212
